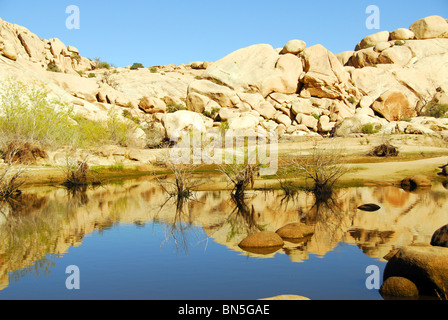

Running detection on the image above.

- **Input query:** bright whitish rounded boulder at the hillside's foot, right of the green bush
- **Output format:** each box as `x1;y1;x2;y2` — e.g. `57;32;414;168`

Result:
162;110;206;141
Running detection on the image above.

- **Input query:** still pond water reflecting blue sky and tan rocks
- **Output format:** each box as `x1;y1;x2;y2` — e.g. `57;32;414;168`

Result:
0;178;448;300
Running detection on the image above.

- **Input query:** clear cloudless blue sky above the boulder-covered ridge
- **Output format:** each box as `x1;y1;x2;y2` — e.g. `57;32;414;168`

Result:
0;0;448;67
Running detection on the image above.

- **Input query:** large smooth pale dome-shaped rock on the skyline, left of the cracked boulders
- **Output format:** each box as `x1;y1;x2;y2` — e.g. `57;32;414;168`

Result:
203;44;279;92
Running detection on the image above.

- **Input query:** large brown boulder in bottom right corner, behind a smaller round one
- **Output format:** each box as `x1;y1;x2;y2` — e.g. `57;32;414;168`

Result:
384;246;448;296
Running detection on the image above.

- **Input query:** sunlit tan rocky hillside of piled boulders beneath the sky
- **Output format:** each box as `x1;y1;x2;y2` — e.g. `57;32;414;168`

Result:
0;16;448;145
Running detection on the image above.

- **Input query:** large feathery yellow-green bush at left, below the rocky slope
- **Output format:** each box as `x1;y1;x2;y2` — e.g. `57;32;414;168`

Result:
0;80;136;150
